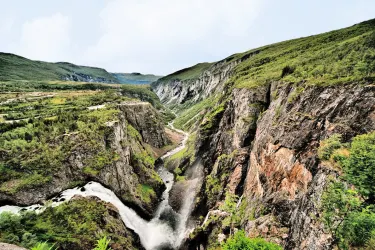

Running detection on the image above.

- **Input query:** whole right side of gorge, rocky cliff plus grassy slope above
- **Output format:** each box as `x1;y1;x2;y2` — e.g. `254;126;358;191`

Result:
153;20;375;249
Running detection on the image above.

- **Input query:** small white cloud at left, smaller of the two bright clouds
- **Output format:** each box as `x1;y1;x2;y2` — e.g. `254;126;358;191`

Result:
19;13;71;61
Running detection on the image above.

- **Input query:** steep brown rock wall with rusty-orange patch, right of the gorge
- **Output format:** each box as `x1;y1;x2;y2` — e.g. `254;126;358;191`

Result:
190;82;375;249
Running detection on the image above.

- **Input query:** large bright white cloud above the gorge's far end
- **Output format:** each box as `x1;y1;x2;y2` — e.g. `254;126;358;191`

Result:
84;0;261;73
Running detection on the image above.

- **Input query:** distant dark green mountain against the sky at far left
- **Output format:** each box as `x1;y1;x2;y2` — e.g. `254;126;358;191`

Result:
0;53;119;83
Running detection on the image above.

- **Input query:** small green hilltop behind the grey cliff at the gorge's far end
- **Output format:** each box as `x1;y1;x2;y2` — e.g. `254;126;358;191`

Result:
158;63;213;83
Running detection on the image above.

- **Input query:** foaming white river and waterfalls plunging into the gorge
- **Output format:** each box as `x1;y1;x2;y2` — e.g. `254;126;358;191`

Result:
0;121;202;250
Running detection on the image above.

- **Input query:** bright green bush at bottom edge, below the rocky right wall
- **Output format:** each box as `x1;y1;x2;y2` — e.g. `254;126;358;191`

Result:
222;231;282;250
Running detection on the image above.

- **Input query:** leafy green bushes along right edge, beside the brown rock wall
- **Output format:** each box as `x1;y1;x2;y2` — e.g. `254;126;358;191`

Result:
319;132;375;249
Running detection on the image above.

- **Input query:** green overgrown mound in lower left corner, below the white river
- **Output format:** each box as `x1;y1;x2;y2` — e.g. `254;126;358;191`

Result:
0;199;133;250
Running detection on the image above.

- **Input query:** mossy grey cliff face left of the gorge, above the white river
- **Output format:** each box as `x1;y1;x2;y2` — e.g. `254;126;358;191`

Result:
0;102;169;218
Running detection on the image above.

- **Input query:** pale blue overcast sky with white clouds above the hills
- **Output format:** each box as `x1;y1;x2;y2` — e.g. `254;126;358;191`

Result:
0;0;375;75
